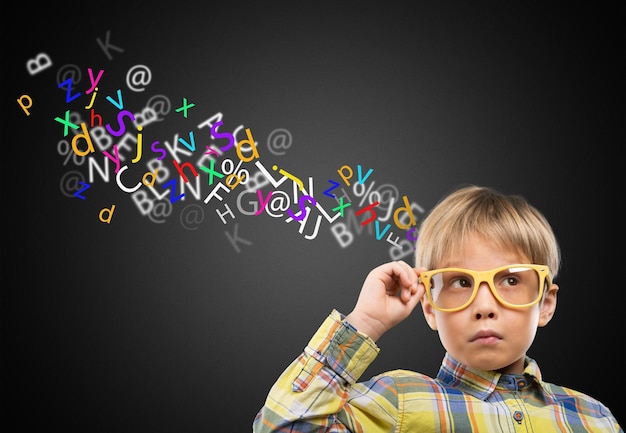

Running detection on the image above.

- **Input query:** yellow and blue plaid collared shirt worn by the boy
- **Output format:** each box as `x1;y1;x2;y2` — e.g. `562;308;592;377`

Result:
253;310;623;433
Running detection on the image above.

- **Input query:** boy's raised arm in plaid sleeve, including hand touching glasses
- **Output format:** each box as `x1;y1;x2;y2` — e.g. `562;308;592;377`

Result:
253;261;424;433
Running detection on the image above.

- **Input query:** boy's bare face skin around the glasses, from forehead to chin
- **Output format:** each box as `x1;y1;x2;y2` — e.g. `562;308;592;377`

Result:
422;236;558;373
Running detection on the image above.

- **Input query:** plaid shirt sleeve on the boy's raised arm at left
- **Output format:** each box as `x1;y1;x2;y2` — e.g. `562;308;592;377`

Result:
253;310;390;433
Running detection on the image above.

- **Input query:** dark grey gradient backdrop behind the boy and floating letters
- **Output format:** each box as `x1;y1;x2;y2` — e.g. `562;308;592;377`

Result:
1;2;626;433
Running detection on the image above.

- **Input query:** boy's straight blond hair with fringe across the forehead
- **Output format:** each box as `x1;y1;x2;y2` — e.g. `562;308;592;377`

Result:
415;185;561;280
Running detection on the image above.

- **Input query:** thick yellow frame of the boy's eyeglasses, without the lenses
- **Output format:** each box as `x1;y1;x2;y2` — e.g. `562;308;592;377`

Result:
419;263;551;313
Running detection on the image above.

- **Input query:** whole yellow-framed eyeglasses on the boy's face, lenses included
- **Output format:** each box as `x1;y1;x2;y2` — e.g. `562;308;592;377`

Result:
420;264;550;312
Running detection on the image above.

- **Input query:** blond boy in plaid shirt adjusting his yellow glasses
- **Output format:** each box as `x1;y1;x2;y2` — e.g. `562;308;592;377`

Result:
253;186;623;433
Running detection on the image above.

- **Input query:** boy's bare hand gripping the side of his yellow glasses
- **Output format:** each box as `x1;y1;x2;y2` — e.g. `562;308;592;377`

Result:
346;260;424;341
